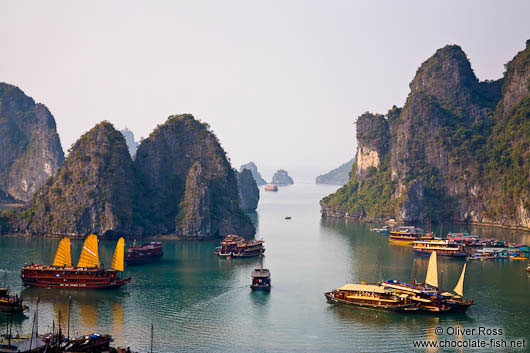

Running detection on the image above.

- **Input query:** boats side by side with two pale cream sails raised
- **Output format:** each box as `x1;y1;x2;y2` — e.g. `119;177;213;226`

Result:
324;252;473;313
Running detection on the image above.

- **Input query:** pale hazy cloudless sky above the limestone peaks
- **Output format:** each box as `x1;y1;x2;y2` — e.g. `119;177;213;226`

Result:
0;0;530;182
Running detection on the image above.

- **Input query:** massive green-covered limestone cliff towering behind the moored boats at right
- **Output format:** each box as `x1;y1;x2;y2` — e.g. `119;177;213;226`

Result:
321;41;530;228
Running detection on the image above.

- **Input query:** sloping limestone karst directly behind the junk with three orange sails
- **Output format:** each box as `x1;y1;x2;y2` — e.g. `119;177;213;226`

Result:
18;122;137;237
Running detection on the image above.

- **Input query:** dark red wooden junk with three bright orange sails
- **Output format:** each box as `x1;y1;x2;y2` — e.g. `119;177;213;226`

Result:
20;234;131;289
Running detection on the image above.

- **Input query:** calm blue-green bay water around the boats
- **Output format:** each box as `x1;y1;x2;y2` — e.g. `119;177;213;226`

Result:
0;184;530;352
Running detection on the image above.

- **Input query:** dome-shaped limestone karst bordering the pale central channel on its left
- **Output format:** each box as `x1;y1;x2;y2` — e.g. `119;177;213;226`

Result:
134;114;255;238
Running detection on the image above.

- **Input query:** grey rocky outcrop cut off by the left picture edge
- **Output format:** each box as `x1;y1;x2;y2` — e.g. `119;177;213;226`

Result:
0;83;64;201
